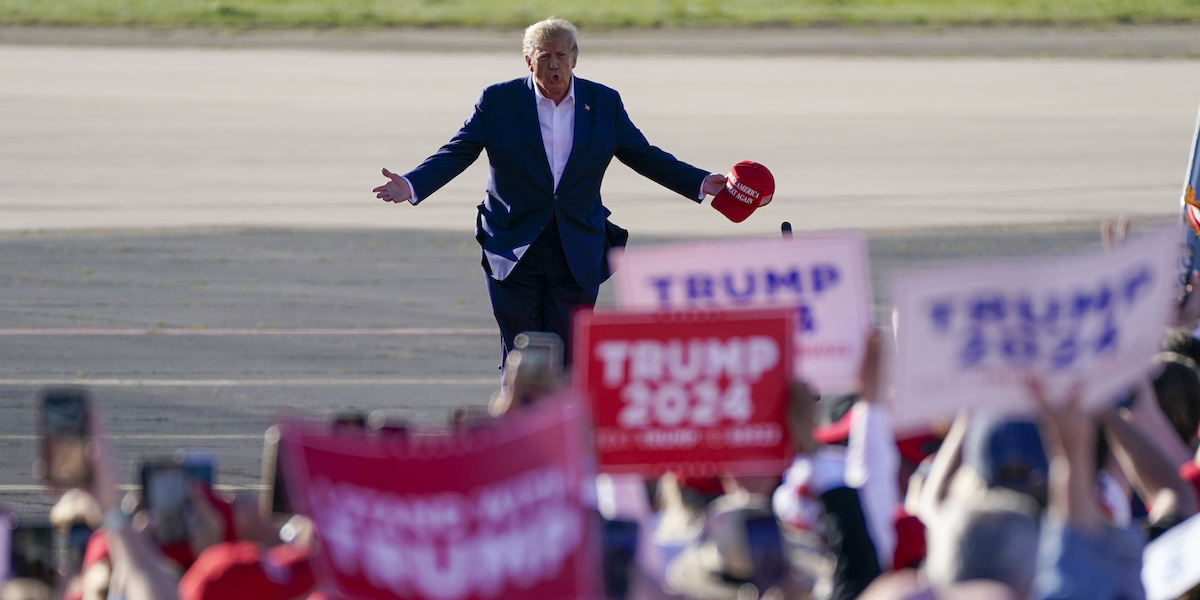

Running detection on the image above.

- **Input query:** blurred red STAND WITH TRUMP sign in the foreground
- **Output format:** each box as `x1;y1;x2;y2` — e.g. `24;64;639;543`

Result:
280;392;601;600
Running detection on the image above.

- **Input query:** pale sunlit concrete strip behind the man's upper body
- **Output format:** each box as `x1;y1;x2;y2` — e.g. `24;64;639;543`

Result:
0;42;1200;236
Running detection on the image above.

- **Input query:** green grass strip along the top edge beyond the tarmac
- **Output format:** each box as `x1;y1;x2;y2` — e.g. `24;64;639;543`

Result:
7;0;1200;29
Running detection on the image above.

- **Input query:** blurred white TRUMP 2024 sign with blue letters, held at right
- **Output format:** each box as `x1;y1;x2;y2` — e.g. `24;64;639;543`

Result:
892;228;1181;428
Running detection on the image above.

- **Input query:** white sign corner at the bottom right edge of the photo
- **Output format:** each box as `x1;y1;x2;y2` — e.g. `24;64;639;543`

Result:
1141;515;1200;600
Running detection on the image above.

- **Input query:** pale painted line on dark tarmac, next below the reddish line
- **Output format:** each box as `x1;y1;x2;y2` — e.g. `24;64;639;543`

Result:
0;376;500;388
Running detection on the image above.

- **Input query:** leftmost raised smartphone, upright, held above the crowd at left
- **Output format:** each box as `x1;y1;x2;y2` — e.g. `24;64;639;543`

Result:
37;388;91;488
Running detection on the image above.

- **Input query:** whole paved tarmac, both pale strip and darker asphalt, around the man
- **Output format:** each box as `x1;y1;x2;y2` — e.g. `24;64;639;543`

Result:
0;24;1200;517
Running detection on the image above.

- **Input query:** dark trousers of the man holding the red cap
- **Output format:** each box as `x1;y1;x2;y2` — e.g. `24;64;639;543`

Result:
485;218;600;365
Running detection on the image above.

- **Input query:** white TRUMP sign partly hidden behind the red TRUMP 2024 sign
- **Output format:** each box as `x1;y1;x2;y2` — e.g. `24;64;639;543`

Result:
611;232;871;392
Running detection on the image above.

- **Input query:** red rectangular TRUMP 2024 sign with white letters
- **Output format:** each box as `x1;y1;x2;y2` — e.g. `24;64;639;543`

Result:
575;308;796;476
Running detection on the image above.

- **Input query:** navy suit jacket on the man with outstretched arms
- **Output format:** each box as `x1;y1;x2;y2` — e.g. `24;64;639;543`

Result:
404;74;708;287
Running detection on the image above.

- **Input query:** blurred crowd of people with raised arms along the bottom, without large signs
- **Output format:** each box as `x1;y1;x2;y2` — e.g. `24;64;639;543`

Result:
0;222;1200;600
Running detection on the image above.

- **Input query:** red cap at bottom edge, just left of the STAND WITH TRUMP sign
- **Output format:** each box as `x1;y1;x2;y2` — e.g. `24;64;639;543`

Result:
179;541;317;600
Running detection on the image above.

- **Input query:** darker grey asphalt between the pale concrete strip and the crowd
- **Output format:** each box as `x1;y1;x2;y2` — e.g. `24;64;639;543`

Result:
0;220;1169;517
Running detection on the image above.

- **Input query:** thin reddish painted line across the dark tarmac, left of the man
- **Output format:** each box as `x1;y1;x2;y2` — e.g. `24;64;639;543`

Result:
0;328;499;336
